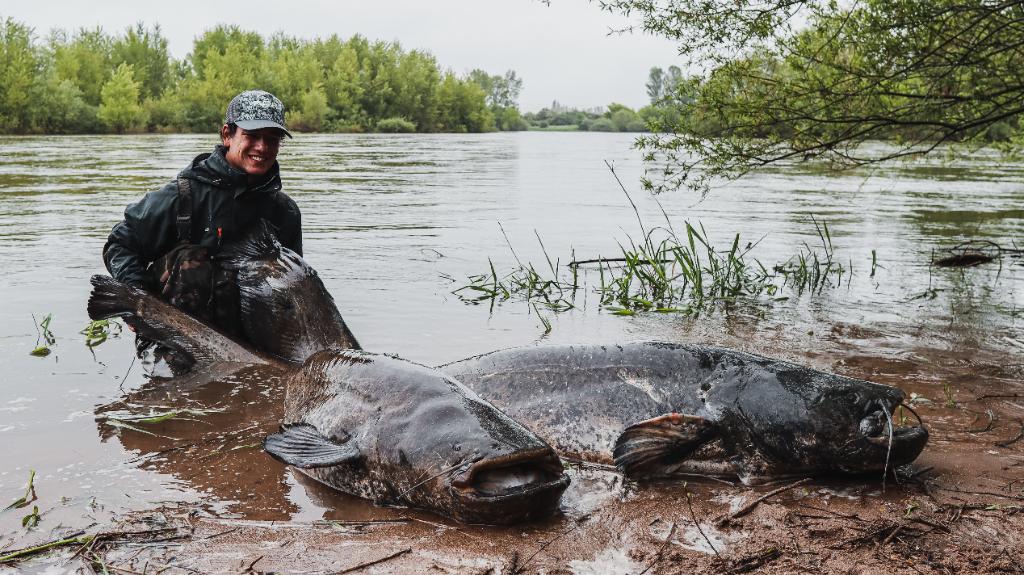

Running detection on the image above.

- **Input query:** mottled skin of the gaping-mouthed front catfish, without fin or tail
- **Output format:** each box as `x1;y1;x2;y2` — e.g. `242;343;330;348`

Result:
285;350;568;524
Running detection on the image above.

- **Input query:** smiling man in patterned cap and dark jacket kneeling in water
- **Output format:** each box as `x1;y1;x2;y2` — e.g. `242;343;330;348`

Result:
103;90;302;334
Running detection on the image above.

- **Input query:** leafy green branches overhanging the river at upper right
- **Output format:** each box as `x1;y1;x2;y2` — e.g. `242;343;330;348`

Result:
603;0;1024;191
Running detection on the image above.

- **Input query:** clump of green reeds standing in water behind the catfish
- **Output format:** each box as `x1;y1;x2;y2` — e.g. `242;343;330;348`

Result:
454;214;849;315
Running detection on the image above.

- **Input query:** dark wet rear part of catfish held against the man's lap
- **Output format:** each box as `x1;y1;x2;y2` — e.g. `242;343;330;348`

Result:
217;221;359;363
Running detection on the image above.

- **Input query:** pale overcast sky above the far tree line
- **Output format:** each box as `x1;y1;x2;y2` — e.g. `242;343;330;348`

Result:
8;0;678;112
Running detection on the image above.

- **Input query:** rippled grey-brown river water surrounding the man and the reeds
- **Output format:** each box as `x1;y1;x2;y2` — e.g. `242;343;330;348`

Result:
0;133;1024;547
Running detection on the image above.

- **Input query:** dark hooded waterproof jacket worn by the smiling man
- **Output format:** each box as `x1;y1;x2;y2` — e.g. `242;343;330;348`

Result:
103;145;302;289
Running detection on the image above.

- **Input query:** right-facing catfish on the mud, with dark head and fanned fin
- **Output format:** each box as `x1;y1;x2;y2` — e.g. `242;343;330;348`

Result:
440;343;928;484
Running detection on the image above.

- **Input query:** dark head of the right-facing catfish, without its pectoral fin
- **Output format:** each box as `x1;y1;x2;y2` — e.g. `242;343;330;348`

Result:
709;363;928;482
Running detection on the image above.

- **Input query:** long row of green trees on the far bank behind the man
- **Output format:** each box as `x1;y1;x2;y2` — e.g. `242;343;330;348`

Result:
0;17;526;134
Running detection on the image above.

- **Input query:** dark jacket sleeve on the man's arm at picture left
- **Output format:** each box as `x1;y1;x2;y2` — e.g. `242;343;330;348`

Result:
103;182;177;288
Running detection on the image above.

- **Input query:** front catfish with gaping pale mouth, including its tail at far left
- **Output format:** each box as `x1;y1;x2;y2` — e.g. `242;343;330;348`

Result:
88;275;568;524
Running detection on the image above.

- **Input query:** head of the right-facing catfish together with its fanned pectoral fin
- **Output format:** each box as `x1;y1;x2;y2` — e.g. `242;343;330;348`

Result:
614;361;928;484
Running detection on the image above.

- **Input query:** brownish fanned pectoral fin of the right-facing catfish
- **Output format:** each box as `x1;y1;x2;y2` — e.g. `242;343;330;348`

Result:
612;413;717;477
